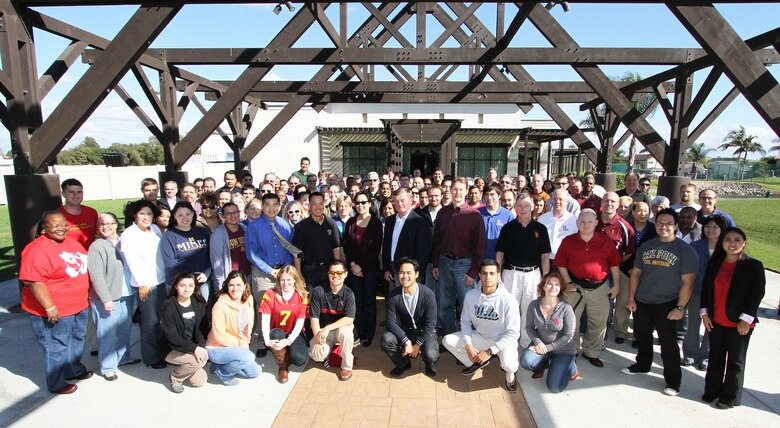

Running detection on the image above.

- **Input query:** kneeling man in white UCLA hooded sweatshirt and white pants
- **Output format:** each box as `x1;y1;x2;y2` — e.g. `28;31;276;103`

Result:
442;259;520;391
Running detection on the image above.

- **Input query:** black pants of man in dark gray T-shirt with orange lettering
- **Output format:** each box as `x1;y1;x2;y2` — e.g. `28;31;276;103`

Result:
634;299;682;390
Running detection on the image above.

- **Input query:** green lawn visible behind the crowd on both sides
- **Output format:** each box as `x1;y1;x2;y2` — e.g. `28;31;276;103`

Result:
0;197;780;280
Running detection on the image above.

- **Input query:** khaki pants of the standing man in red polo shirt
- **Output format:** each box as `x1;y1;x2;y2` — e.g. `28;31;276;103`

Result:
566;281;609;358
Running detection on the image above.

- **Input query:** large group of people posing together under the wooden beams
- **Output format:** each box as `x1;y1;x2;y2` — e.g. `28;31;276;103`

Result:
19;163;765;408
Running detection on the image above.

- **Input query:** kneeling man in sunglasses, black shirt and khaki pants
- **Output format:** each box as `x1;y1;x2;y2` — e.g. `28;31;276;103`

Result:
309;260;356;380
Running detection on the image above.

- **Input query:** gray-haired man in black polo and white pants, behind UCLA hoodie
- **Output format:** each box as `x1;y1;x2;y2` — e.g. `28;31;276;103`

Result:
496;192;550;348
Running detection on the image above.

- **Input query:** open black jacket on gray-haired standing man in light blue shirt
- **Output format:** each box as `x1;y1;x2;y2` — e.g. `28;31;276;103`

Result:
382;210;433;274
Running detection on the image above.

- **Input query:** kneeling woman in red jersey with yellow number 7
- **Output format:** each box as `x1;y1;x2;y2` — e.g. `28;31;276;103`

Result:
258;266;309;383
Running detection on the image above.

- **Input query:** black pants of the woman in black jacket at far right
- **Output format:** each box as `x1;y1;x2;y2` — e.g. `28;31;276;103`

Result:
704;323;753;406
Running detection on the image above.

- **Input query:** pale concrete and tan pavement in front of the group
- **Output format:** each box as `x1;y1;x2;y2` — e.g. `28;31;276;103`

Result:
0;272;780;428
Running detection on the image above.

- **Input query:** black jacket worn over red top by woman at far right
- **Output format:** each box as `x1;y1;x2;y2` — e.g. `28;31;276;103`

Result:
701;258;766;323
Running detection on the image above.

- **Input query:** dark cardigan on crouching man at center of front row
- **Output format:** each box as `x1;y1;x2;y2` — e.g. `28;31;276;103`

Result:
387;283;437;346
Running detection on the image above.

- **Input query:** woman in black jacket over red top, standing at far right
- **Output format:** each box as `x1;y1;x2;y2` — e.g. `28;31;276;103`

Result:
699;227;766;409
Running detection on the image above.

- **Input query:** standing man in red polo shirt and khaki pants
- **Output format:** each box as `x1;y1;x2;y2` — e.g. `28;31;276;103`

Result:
555;208;621;367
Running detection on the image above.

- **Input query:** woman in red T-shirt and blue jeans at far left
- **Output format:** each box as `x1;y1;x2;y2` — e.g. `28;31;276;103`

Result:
19;211;92;394
